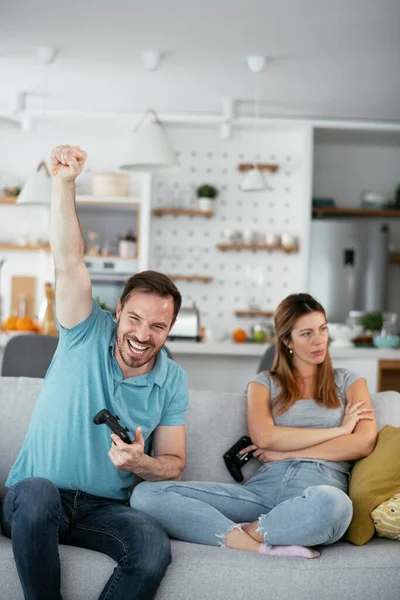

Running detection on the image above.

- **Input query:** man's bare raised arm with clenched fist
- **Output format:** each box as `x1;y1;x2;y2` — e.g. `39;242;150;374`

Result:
50;146;92;329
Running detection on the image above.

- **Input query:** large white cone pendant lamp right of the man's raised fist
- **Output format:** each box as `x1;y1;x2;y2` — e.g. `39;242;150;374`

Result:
119;110;177;171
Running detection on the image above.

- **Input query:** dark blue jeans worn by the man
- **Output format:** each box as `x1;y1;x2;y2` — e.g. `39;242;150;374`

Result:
1;477;171;600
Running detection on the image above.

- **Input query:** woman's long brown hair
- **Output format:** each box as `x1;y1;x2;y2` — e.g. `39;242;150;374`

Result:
270;294;340;414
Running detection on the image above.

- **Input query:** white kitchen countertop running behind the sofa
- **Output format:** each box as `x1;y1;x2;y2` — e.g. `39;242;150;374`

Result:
0;334;400;360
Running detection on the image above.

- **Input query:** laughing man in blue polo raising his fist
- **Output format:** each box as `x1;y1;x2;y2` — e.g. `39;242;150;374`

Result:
2;146;188;600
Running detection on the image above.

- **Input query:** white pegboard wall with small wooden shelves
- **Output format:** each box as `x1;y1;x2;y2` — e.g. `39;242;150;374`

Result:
150;127;311;332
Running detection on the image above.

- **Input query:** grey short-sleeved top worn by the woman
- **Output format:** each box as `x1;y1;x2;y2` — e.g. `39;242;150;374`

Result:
250;369;360;473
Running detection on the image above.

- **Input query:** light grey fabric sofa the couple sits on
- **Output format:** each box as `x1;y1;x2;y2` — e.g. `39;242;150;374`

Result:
0;377;400;600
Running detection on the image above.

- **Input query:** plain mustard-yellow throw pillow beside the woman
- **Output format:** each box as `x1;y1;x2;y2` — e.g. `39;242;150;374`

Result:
346;425;400;546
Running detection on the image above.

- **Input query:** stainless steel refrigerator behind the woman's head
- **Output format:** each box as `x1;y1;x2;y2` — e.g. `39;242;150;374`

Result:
309;219;389;323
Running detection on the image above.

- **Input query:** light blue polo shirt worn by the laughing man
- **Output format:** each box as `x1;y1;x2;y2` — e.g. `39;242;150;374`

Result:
6;301;188;500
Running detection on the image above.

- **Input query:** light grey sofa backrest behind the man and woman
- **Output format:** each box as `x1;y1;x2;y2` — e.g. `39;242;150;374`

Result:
0;377;400;497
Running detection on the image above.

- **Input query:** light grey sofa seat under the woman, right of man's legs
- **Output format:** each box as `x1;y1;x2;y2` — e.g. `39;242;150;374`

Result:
156;539;400;600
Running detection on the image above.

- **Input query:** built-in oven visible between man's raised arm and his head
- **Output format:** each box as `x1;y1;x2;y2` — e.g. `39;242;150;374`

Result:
85;256;138;312
